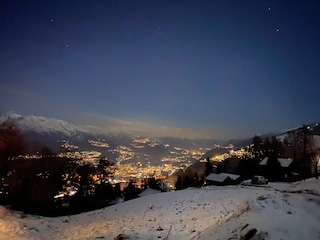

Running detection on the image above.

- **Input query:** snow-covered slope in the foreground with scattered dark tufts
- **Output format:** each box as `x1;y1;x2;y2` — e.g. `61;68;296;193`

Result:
0;179;320;240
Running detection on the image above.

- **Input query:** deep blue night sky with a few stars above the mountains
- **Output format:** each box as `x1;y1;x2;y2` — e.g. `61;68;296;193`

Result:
0;0;320;138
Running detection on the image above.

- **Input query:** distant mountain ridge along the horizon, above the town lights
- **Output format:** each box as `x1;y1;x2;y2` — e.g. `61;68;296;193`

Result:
0;112;320;157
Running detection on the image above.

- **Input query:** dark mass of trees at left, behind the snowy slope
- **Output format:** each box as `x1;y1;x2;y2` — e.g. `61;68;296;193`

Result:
0;122;122;216
